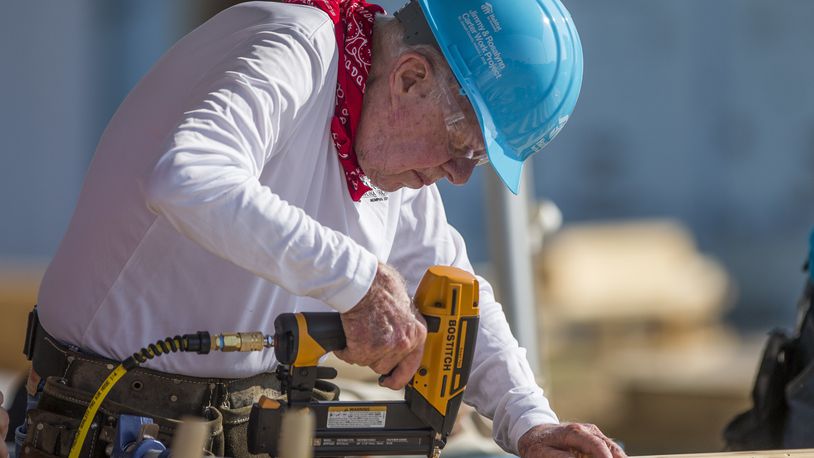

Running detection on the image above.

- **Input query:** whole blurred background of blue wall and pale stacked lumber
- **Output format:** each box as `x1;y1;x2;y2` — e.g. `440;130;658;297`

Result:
0;0;814;454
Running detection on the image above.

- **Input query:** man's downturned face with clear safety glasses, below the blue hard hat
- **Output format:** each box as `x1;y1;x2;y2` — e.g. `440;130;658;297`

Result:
355;53;484;191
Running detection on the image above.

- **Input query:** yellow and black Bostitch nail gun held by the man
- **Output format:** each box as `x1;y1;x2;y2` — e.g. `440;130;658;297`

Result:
248;266;479;457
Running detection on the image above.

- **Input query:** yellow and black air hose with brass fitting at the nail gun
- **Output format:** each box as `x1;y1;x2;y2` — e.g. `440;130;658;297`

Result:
68;331;274;458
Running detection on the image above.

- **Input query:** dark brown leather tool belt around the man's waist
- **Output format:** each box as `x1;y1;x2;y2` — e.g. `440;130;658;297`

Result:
22;309;339;457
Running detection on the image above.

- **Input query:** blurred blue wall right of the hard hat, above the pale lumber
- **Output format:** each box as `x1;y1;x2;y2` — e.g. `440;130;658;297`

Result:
535;0;814;327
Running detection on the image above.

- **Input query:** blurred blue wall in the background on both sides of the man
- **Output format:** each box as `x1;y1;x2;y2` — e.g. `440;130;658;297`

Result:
0;0;814;328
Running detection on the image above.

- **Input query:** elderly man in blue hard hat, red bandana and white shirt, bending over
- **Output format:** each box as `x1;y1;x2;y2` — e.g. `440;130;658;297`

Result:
26;0;624;458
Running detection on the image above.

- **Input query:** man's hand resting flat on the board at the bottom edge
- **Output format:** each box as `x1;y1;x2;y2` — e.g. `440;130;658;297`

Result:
517;423;627;458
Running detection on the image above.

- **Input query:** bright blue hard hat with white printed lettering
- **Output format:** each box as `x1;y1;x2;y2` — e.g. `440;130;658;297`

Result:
404;0;582;194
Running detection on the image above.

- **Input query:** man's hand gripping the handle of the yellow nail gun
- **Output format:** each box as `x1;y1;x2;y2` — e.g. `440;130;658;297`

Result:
334;263;427;390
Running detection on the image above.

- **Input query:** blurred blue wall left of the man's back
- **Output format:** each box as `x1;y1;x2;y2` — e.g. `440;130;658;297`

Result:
0;0;188;259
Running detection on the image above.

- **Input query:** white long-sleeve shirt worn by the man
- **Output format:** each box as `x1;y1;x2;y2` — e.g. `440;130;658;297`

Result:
39;2;557;451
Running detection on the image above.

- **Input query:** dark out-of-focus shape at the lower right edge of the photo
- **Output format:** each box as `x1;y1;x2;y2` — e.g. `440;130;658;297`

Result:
724;256;814;451
